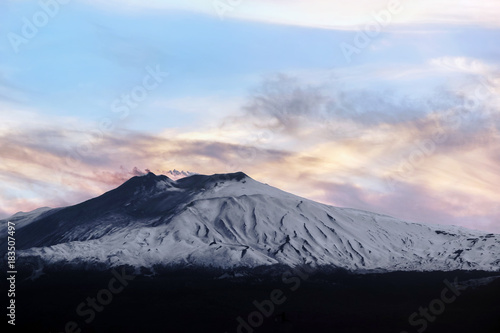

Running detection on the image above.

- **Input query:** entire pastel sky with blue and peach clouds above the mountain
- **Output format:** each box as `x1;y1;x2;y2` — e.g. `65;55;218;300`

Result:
0;0;500;233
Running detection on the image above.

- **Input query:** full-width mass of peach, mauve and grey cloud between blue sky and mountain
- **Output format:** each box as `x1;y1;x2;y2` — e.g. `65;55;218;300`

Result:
0;58;500;232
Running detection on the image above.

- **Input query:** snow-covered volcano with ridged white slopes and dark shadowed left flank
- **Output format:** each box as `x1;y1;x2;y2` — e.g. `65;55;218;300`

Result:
0;172;500;271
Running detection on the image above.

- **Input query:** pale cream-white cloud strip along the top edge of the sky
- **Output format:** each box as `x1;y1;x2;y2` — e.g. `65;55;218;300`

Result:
83;0;500;30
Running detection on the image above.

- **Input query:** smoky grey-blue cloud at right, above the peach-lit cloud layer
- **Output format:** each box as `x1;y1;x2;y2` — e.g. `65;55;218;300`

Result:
237;58;500;142
